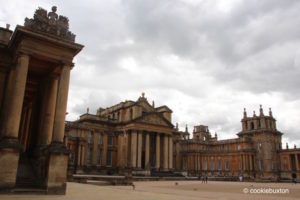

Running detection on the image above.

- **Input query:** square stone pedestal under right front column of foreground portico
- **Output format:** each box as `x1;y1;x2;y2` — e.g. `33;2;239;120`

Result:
47;143;69;194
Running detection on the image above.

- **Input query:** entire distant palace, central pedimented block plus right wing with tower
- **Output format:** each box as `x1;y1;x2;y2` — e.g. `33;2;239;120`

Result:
65;94;300;181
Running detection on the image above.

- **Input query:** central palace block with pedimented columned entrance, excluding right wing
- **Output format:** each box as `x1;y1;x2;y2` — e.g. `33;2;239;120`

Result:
66;94;173;175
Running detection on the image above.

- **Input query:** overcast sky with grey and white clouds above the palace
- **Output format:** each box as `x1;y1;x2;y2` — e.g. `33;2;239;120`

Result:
0;0;300;146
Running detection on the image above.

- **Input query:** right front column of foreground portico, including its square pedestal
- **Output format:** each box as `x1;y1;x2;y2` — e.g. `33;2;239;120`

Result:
47;65;71;194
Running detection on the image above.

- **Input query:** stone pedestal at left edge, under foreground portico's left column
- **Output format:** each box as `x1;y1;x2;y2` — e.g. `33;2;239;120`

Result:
0;148;20;193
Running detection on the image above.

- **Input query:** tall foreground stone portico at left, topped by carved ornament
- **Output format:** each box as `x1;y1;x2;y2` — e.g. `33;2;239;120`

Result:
0;7;83;194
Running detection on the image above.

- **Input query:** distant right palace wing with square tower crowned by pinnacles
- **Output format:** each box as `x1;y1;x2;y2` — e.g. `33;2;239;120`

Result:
174;107;300;181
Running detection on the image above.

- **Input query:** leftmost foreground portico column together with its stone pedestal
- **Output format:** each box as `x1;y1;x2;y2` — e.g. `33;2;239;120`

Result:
0;54;29;190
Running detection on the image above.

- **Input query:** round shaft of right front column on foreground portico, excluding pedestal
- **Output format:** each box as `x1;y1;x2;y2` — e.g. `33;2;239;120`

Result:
52;65;71;143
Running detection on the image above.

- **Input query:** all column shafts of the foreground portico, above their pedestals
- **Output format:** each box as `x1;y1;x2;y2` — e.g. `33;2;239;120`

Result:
1;54;71;148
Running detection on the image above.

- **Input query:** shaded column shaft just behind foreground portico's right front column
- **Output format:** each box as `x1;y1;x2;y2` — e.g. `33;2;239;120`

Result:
39;78;58;145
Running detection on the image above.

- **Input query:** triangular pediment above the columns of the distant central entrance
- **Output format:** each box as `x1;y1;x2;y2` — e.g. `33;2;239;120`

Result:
135;113;173;128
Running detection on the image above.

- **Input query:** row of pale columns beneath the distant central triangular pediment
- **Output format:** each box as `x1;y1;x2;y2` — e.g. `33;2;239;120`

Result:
130;131;173;170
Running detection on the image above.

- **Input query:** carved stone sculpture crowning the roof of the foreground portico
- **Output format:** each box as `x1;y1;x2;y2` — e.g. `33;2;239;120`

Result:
24;6;75;42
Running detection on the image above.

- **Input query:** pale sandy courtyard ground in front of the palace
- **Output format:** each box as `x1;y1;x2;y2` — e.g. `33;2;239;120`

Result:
0;181;300;200
